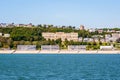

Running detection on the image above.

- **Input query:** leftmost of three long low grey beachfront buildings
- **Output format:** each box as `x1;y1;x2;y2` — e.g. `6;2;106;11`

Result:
17;45;36;51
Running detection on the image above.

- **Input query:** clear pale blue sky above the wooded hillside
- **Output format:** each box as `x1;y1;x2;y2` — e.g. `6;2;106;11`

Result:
0;0;120;28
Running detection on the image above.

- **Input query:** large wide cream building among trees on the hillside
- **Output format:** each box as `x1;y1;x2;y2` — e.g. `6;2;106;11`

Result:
42;32;78;41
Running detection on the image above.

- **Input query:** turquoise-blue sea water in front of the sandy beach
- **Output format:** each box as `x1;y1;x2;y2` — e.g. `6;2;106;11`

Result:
0;54;120;80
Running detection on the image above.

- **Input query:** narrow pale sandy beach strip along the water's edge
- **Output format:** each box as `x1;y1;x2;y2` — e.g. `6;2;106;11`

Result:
0;50;120;54
